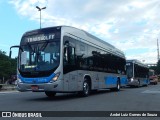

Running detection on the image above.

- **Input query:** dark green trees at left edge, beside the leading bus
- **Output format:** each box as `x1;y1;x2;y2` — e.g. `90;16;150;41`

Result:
0;50;17;80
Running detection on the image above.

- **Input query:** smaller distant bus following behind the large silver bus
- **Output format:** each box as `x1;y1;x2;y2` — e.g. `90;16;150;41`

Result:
126;59;149;87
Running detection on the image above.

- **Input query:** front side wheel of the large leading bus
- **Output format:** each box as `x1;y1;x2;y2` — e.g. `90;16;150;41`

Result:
82;80;90;97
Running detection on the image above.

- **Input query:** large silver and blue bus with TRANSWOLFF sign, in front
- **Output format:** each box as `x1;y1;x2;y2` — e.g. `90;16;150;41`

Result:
10;26;127;97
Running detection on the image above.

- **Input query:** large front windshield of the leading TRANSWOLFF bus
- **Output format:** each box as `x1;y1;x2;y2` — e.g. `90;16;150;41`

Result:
19;41;60;72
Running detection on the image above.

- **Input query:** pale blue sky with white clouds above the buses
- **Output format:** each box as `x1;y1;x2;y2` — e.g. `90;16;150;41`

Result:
0;0;160;63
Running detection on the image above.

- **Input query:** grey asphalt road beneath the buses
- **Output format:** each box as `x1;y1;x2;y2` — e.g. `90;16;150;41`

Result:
0;83;160;120
